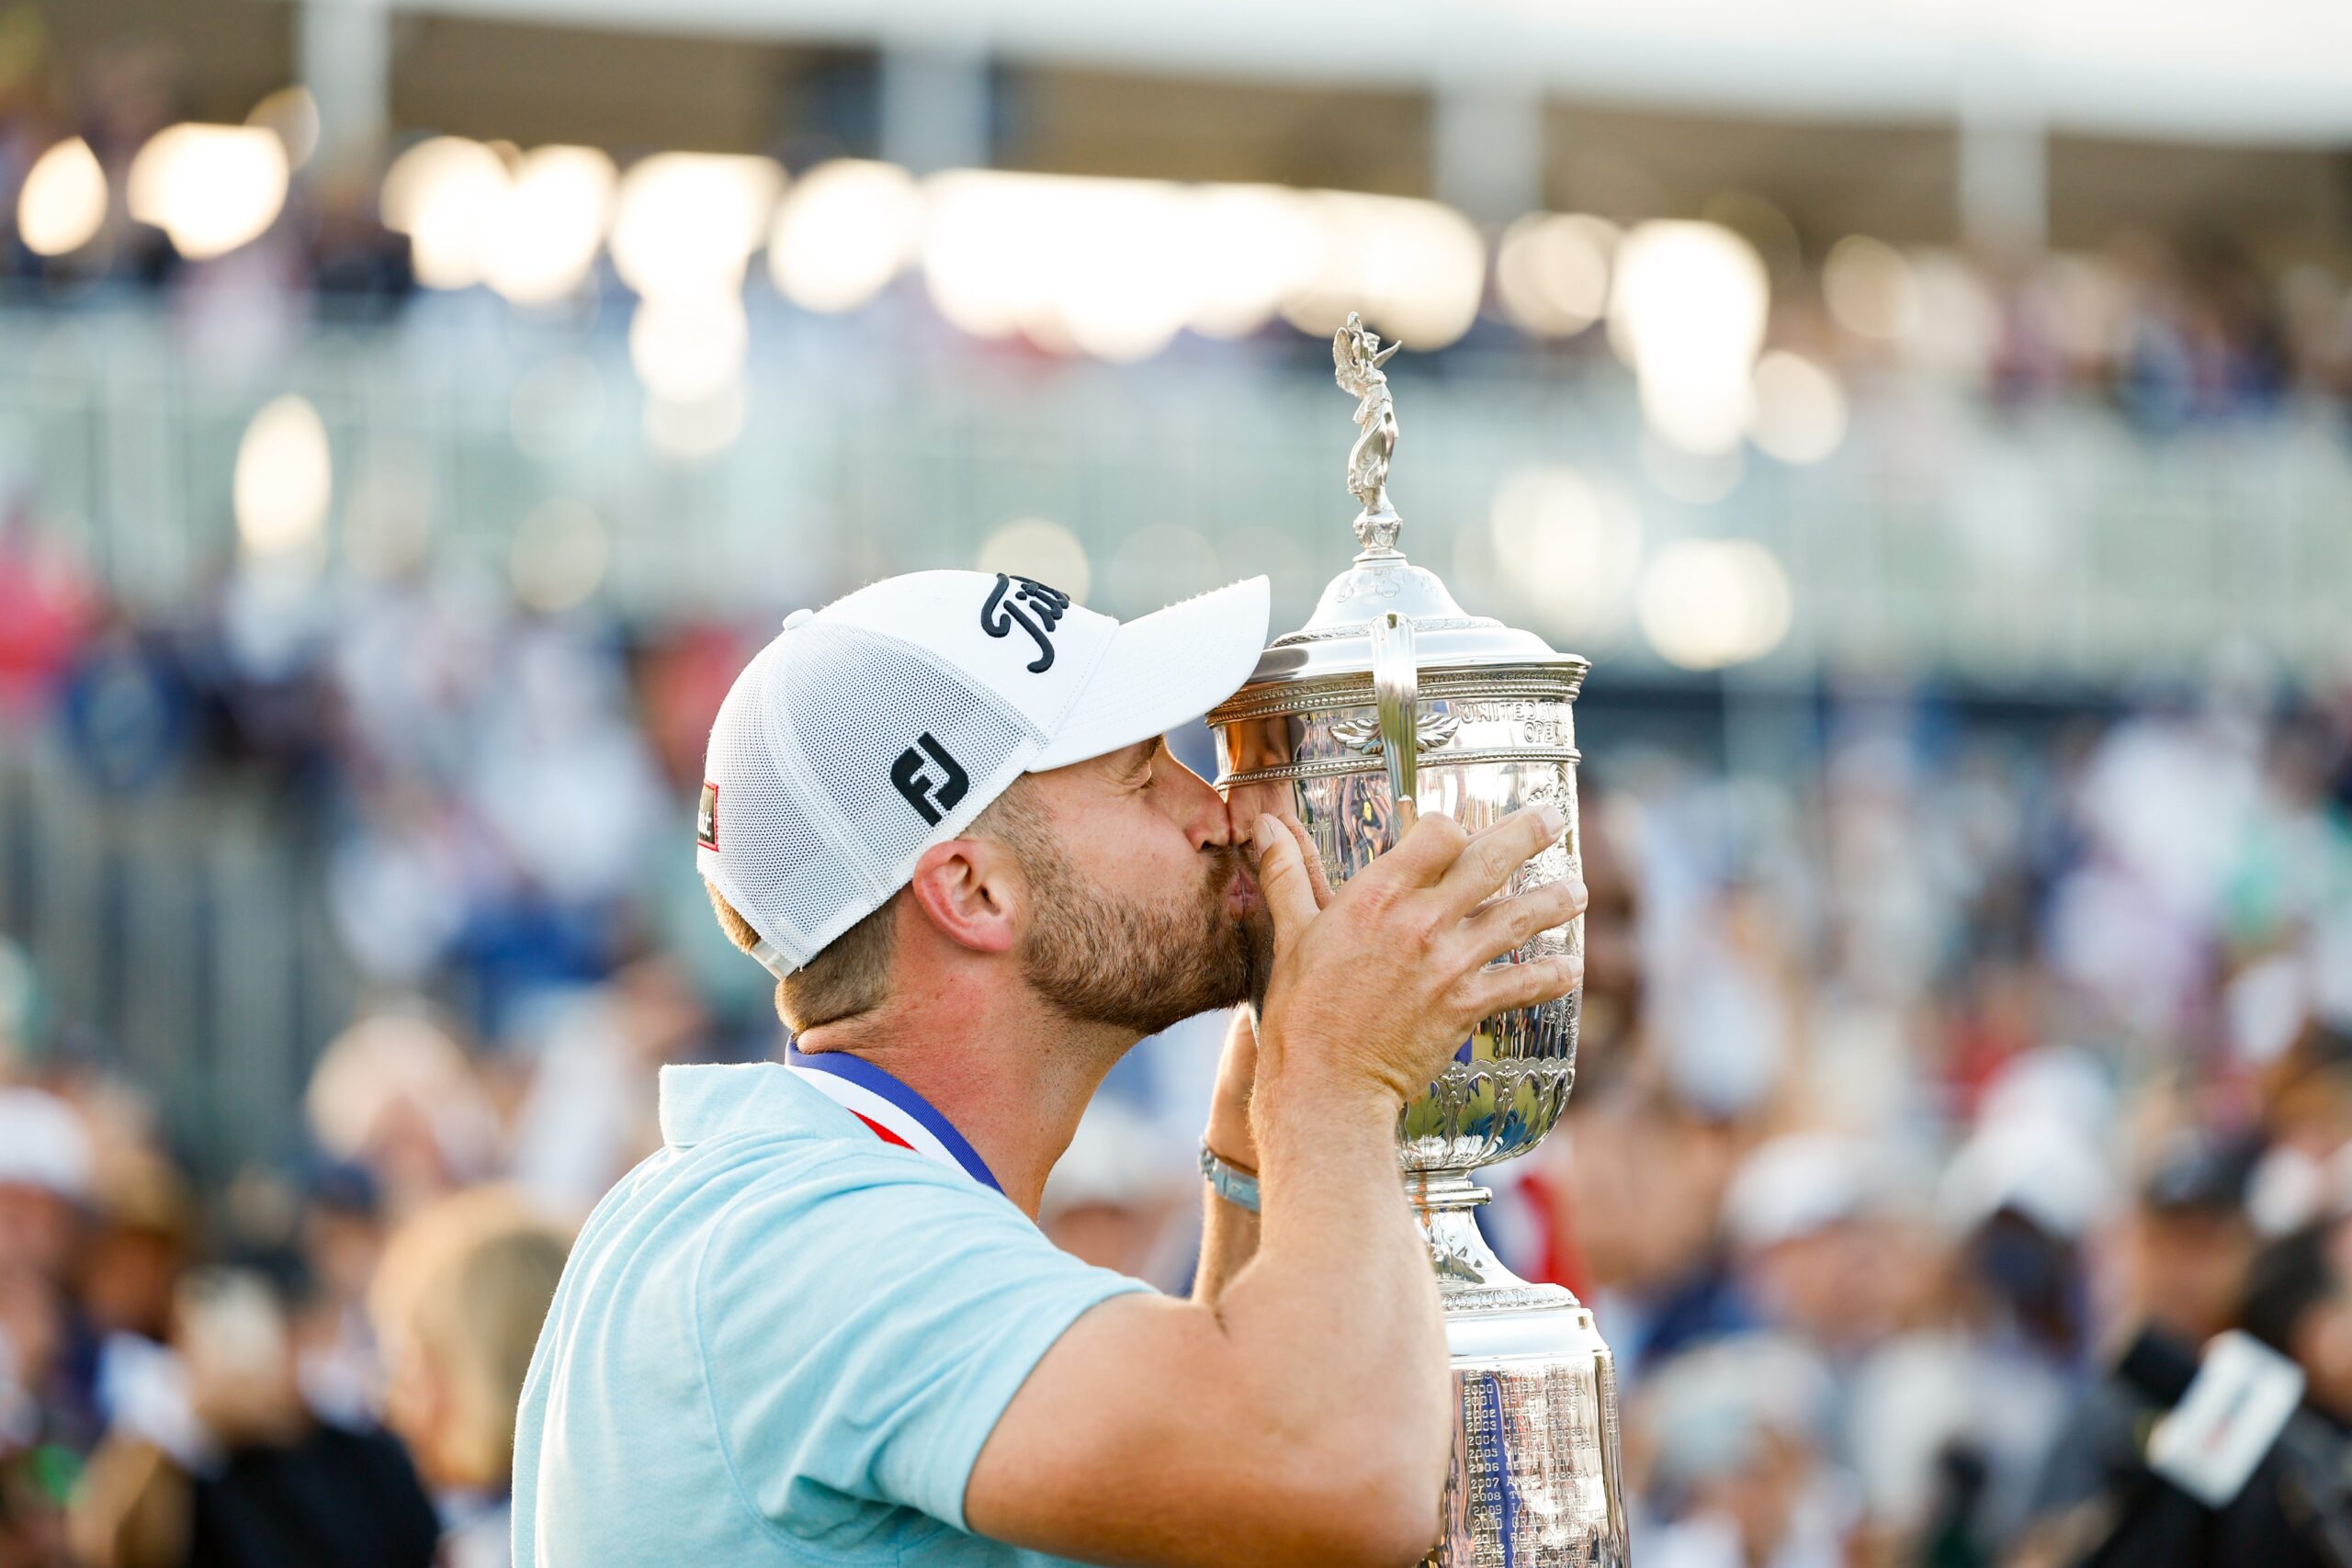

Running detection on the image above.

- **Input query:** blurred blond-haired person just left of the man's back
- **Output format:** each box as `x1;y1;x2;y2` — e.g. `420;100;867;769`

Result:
369;1187;567;1568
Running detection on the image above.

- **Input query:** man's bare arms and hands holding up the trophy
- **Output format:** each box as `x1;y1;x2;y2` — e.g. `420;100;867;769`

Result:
965;811;1583;1568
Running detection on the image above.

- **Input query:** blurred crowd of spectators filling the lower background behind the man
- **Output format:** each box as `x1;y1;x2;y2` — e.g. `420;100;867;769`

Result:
14;465;2352;1568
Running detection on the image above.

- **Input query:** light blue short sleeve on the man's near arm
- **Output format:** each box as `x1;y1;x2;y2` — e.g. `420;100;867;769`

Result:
694;1149;1150;1530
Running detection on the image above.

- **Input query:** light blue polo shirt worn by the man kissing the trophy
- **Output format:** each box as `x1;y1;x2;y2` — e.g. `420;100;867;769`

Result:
515;1063;1148;1568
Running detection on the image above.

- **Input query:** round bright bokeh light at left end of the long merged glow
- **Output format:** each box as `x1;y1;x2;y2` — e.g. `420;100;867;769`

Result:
767;157;922;312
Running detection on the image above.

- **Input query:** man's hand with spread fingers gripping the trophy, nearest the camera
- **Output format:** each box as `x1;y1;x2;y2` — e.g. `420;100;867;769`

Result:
1253;807;1585;1102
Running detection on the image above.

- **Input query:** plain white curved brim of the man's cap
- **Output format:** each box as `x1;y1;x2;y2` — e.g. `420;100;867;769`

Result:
1028;576;1268;773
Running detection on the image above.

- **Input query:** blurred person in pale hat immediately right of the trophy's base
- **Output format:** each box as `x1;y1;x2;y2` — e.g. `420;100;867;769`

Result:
1625;1333;1858;1568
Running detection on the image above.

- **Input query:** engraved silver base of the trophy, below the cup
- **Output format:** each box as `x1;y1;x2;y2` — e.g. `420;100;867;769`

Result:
1414;1173;1630;1568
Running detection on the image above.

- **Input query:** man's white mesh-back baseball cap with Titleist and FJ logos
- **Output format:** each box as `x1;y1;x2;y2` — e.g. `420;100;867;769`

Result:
694;571;1268;976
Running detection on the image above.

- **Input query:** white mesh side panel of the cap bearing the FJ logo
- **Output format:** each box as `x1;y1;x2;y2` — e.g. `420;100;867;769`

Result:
769;621;1037;888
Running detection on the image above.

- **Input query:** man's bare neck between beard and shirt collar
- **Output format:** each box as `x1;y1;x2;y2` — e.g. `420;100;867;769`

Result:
795;978;1138;1220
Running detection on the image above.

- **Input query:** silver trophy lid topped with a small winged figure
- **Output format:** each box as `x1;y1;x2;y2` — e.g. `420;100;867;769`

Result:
1249;310;1585;686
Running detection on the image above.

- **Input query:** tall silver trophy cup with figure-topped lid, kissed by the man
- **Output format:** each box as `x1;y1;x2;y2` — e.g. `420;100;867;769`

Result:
1209;315;1628;1568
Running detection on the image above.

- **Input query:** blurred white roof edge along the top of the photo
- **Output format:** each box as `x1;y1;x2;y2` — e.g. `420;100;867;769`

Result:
390;0;2352;143
